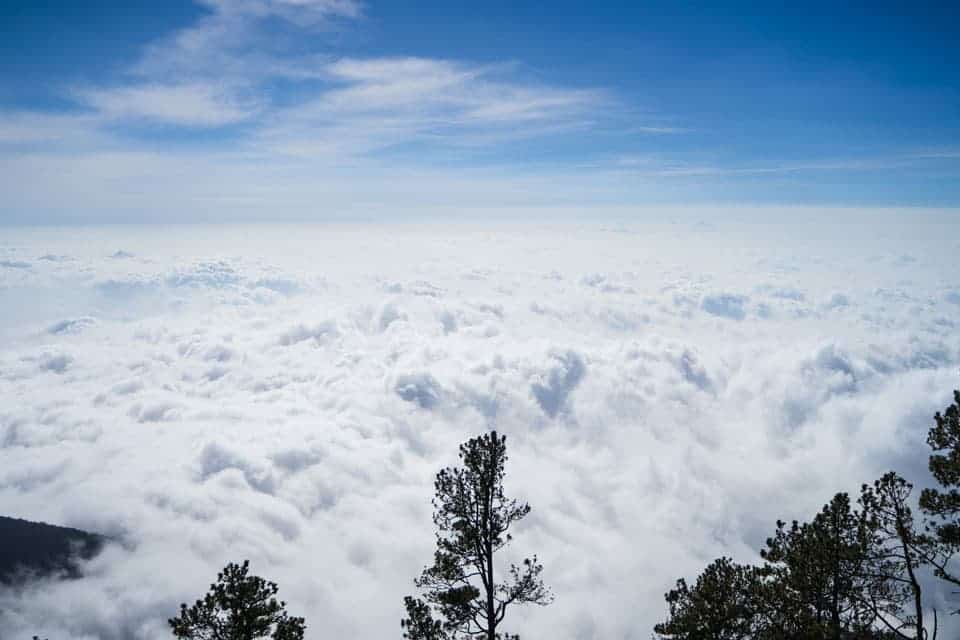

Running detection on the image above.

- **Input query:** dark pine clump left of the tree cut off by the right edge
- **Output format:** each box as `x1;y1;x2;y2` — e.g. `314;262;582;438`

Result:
654;492;925;640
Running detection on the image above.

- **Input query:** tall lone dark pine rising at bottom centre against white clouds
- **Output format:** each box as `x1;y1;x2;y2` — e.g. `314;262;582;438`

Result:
401;431;552;640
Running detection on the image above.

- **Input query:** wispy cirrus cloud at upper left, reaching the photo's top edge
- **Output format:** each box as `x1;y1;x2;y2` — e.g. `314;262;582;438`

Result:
67;0;361;127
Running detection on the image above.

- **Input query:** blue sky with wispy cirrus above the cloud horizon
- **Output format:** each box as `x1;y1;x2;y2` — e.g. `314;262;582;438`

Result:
0;0;960;222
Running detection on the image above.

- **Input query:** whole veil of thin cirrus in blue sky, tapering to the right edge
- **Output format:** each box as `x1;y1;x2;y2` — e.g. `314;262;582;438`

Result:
0;0;957;221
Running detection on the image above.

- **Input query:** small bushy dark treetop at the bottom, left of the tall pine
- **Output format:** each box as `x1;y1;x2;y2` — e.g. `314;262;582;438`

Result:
168;560;306;640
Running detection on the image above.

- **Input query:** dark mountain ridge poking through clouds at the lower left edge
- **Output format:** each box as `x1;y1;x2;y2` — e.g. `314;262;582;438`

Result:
0;516;106;584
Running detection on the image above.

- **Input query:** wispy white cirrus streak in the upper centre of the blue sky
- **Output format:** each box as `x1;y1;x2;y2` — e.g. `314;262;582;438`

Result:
260;58;609;156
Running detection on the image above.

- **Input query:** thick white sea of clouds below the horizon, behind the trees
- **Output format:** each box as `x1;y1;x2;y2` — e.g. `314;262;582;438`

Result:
0;217;960;640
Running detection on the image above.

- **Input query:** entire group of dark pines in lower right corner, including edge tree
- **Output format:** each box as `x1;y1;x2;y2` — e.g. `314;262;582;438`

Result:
654;391;960;640
